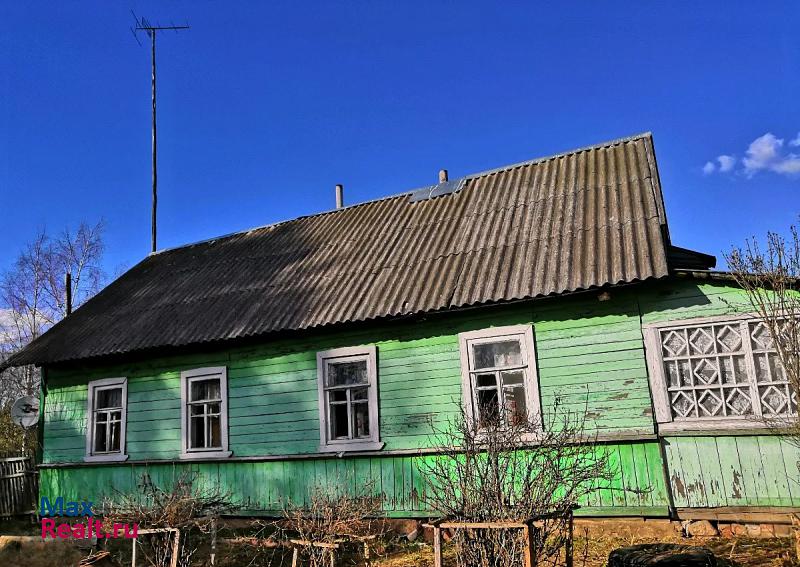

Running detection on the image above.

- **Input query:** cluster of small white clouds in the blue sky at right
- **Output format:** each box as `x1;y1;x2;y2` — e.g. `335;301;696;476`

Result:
703;132;800;177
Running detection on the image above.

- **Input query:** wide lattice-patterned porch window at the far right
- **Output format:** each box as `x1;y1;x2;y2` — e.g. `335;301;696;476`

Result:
646;317;797;431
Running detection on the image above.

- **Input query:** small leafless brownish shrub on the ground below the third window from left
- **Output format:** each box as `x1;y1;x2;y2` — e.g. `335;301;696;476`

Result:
282;479;383;567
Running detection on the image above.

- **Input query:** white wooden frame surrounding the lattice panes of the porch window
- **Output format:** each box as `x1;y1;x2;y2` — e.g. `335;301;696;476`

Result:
642;313;783;433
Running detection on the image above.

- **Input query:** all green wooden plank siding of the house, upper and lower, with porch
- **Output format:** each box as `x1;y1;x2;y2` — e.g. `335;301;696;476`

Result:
41;280;800;517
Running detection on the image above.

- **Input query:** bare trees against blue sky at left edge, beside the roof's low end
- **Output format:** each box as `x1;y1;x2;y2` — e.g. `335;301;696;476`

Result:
0;221;104;405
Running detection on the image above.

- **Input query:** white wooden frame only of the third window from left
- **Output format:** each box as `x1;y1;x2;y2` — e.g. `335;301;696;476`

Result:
317;346;384;453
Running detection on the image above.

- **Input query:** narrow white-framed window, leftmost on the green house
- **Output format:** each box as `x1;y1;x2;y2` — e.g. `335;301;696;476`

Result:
84;378;128;462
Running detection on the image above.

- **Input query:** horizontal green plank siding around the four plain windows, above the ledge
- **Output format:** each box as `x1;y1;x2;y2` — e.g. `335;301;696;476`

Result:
44;288;653;463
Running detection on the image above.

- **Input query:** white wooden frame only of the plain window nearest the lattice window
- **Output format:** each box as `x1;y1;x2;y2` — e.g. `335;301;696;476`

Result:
458;325;542;427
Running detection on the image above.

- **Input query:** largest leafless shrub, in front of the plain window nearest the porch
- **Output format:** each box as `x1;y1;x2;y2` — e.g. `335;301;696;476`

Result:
423;401;615;567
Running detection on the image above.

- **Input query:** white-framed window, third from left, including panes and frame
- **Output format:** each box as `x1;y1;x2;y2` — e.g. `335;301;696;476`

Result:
317;346;383;451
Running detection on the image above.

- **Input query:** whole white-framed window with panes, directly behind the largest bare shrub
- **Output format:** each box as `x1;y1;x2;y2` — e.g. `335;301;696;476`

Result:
459;325;540;426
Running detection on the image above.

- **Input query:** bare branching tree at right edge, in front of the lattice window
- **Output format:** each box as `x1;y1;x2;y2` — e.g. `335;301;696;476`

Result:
725;220;800;432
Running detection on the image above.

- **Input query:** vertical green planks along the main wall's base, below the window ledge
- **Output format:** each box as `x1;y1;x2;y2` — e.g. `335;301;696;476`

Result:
41;442;667;517
